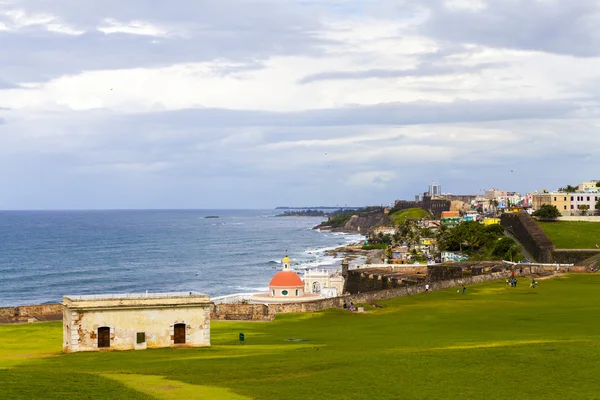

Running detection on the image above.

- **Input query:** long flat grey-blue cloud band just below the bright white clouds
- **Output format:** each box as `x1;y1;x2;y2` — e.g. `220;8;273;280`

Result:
132;99;580;126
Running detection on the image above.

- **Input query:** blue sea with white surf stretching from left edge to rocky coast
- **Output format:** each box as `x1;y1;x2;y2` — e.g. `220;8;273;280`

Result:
0;210;358;306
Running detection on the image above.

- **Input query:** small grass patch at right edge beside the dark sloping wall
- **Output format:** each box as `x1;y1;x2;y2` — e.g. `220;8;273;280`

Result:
538;221;600;249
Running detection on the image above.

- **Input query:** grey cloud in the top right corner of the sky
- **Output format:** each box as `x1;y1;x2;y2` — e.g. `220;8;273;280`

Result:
419;0;600;57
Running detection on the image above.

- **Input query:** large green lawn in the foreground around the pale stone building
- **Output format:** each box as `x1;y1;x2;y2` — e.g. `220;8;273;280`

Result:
0;274;600;400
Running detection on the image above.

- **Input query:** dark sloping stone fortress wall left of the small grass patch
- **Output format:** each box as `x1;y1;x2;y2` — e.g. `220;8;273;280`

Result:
500;213;554;263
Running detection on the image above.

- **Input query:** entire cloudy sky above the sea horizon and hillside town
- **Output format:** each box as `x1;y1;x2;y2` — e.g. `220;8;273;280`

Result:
0;0;600;210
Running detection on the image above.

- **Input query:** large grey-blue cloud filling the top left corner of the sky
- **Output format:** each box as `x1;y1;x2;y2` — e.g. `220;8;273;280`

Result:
0;0;328;81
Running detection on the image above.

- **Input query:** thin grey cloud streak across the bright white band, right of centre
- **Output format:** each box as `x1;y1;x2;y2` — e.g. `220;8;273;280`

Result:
299;63;507;83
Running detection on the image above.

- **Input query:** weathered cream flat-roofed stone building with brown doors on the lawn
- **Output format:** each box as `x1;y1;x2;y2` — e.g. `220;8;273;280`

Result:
62;292;211;353
